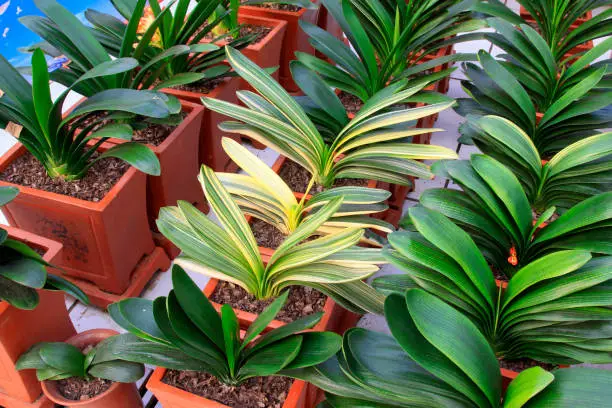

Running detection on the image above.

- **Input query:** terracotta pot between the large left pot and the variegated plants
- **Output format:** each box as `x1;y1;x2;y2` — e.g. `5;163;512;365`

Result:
100;101;208;231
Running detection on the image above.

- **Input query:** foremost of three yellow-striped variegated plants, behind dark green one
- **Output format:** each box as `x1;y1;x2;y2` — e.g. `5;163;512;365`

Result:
157;166;383;312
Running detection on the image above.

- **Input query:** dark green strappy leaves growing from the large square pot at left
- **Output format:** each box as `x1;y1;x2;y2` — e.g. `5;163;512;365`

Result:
0;50;167;180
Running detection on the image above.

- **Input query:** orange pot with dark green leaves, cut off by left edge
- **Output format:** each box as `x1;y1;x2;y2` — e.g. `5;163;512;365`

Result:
0;187;88;407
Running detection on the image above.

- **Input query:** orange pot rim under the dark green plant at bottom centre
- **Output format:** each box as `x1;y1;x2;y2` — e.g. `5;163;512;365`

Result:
147;367;310;408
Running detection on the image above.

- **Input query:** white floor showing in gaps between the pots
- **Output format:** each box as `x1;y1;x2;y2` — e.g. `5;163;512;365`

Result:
0;0;612;405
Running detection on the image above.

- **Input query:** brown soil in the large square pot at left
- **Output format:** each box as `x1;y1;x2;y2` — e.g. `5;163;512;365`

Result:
0;152;130;202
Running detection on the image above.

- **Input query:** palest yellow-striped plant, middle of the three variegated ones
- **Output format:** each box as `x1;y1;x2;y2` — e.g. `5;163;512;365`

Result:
217;138;394;245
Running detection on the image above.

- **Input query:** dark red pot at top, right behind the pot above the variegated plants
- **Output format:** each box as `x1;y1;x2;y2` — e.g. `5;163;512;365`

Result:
240;6;319;92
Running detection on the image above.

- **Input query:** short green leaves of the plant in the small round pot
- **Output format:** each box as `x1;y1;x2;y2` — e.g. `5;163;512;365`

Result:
16;337;144;383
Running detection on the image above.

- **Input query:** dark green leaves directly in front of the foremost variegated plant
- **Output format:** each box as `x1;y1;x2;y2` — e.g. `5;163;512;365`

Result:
104;265;341;386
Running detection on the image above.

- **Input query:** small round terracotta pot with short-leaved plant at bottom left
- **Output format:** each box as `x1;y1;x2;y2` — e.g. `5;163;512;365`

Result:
17;329;144;408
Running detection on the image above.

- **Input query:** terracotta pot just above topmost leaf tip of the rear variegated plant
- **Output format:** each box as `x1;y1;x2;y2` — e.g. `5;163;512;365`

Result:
238;13;287;90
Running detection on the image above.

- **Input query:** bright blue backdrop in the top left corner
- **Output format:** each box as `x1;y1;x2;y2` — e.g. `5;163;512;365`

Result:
0;0;113;66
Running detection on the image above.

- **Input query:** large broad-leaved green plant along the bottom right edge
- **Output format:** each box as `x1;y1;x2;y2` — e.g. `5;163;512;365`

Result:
291;289;612;408
